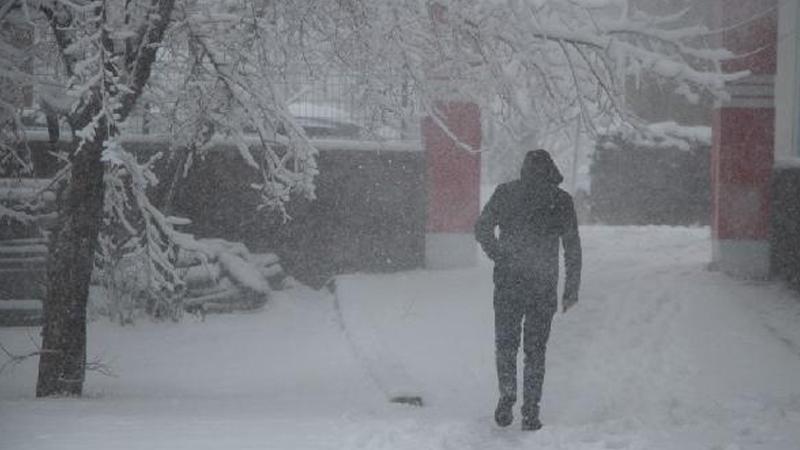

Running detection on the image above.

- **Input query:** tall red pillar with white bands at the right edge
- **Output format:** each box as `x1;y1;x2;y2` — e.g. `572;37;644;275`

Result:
711;0;778;278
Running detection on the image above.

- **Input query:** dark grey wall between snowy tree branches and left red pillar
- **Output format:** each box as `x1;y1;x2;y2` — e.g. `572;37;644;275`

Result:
174;141;427;286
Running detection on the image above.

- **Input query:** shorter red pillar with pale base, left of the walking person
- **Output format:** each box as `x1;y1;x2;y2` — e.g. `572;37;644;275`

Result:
422;102;481;269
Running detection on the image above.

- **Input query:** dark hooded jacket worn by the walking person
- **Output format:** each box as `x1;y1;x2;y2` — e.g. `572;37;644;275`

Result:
475;150;581;301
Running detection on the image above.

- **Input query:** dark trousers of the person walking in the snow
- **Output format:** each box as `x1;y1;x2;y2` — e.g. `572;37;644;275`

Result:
494;273;557;419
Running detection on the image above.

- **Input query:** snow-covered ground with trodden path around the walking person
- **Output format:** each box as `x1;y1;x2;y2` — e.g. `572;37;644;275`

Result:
0;227;800;450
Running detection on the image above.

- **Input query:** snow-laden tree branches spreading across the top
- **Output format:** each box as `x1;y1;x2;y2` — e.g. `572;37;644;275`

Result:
0;0;744;326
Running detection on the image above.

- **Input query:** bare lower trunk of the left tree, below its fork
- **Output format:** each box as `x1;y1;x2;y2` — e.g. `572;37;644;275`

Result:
36;120;108;397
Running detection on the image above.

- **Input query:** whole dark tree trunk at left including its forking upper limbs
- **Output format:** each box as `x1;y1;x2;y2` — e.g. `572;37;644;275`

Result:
36;0;175;397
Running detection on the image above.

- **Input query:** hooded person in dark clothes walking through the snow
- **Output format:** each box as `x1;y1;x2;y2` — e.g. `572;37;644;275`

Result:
475;150;581;430
